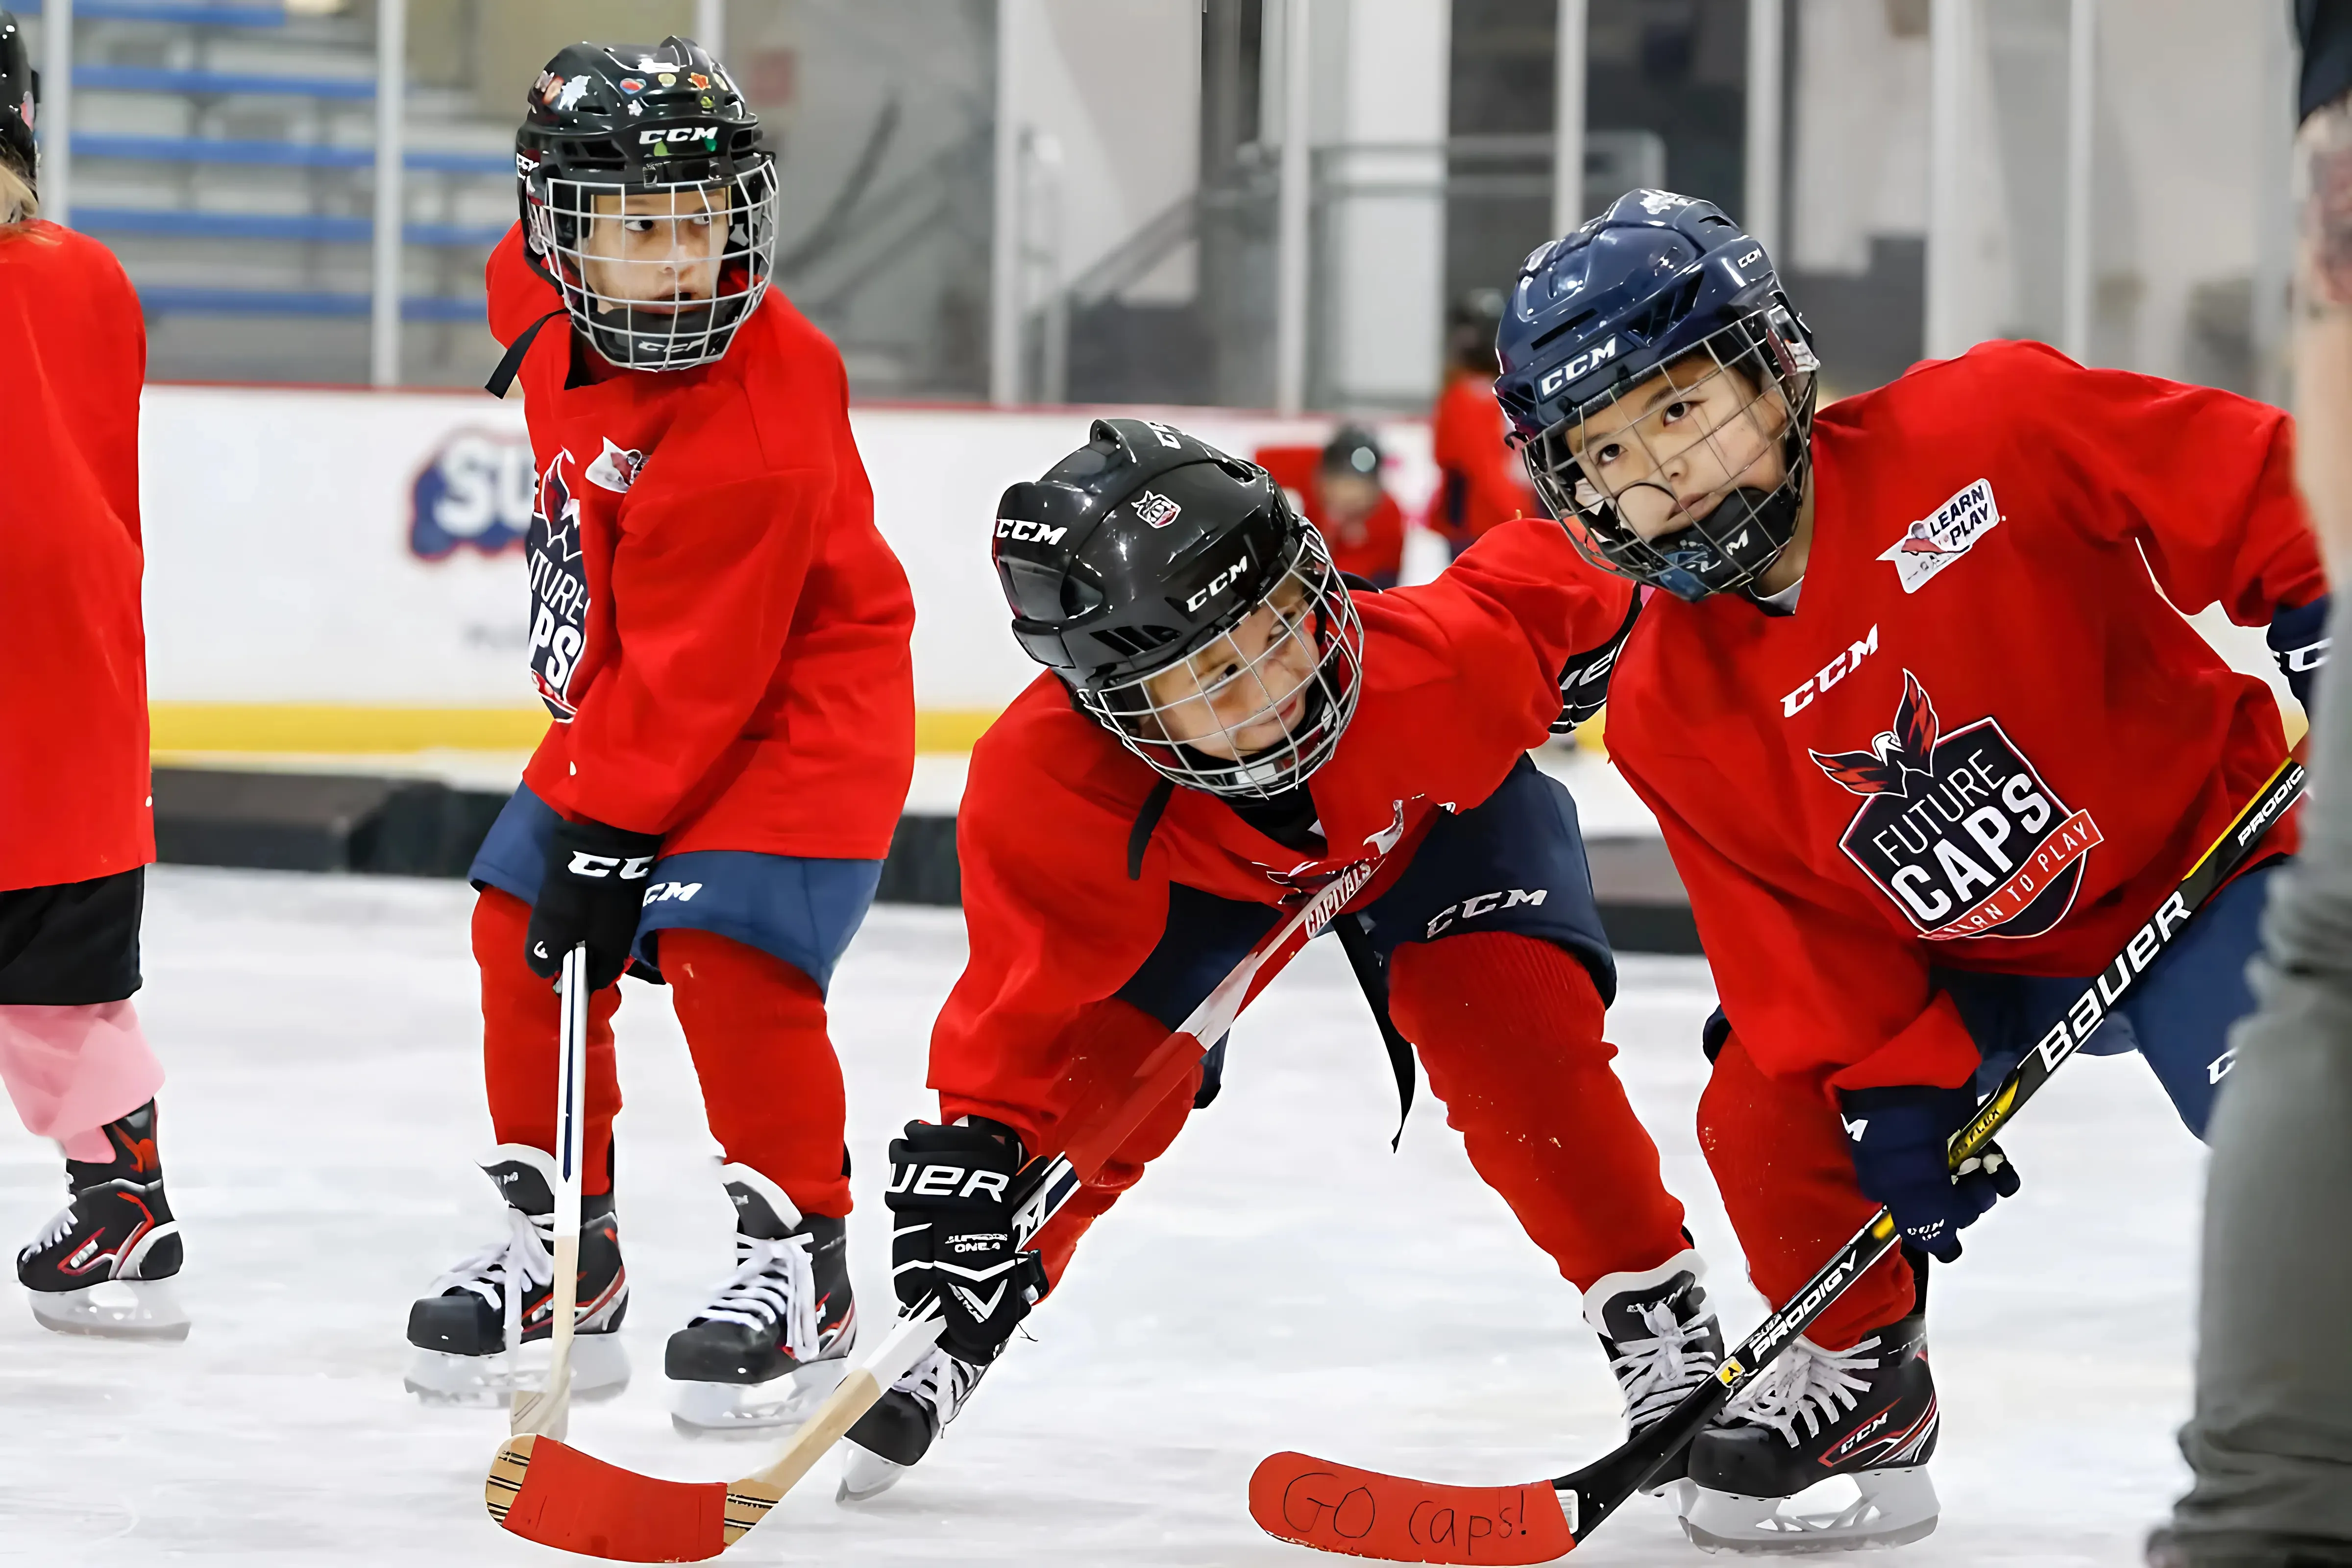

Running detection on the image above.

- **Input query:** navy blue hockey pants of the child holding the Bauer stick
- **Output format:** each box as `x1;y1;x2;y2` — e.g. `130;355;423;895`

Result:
1936;860;2284;1138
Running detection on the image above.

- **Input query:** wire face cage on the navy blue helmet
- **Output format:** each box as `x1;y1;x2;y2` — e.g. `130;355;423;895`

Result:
1526;303;1820;599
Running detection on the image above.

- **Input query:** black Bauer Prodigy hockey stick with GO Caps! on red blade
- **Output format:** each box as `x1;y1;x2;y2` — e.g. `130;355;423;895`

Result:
1249;760;2303;1563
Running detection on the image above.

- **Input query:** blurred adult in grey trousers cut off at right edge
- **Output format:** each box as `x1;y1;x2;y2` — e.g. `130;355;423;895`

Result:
2147;0;2352;1568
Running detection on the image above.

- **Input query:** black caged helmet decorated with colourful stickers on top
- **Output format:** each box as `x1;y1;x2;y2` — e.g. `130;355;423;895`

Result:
515;38;776;371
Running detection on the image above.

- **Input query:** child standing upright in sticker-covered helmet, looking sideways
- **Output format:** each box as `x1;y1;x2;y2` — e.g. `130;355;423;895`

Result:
409;38;915;1429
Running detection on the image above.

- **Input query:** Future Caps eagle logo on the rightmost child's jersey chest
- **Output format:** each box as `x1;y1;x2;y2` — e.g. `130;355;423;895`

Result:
1813;670;2100;940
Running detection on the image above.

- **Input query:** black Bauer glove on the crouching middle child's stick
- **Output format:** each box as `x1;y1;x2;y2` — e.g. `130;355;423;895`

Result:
884;1121;1047;1366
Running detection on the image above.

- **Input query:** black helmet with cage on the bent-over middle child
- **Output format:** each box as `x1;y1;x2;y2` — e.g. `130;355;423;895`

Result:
993;418;1364;799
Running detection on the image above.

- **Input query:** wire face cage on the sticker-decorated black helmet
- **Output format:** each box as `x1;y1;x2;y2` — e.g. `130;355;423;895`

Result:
529;155;776;371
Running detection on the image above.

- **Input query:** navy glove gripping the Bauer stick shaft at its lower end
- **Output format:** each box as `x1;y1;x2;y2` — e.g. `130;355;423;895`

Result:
1837;1088;2018;1262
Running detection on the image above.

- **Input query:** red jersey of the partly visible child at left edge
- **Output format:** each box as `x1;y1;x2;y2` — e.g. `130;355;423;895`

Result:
0;223;155;888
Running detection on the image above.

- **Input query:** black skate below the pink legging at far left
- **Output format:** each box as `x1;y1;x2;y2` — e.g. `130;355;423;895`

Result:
17;1100;188;1340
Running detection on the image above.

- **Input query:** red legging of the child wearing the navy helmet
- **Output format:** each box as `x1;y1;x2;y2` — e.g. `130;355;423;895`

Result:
1698;1034;1912;1349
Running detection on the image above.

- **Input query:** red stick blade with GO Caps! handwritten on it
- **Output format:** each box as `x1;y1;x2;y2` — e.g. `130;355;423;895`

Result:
1249;1453;1576;1563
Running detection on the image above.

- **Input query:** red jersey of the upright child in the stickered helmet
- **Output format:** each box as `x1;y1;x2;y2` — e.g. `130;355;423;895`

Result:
489;228;915;860
